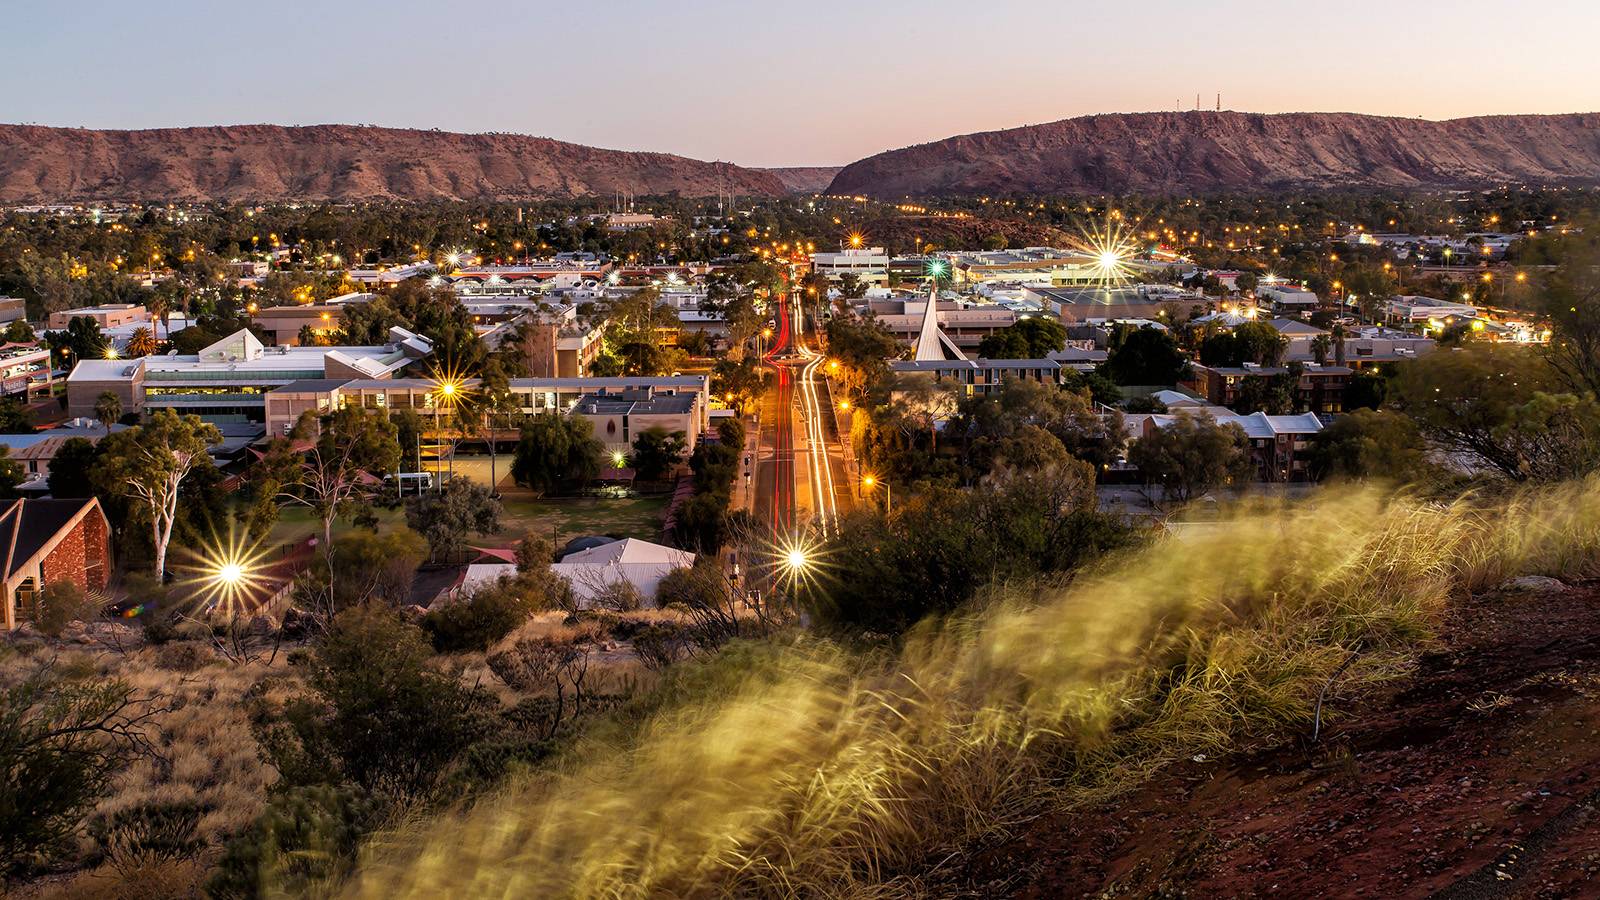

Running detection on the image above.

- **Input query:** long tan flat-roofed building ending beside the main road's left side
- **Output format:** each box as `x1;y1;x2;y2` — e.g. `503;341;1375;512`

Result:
266;375;710;436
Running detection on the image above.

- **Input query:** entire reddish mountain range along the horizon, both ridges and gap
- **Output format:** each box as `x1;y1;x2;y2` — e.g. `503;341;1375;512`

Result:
9;112;1600;203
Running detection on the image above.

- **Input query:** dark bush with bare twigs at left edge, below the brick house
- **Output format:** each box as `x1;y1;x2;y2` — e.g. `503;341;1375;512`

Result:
0;660;162;882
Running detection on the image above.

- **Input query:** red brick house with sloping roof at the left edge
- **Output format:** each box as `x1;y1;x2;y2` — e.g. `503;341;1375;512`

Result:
0;498;110;631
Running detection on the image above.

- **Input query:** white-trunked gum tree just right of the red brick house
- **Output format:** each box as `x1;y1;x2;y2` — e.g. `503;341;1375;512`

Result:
94;410;222;578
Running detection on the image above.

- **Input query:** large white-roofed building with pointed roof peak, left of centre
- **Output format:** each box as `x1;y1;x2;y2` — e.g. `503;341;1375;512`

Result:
67;328;434;423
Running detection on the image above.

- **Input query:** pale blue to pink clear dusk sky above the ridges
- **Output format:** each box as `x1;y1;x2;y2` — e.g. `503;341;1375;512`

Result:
12;0;1600;165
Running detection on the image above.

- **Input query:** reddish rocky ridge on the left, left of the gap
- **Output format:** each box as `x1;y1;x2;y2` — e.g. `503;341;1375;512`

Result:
0;125;786;203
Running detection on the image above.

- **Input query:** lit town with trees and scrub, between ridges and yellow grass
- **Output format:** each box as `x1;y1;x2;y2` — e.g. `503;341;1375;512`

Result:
0;189;1600;897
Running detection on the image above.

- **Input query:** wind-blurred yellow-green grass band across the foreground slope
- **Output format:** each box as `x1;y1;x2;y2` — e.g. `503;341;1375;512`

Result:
347;482;1600;897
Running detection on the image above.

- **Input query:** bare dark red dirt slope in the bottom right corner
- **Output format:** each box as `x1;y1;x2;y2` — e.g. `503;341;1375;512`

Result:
949;585;1600;900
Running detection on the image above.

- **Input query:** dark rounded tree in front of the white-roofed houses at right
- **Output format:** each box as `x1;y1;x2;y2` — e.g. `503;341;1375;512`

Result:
1128;412;1251;503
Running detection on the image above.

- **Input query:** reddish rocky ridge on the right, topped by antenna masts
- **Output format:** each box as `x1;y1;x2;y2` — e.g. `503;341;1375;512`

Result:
827;112;1600;197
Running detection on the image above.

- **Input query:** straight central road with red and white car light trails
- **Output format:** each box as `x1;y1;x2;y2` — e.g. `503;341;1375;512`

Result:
755;291;851;543
